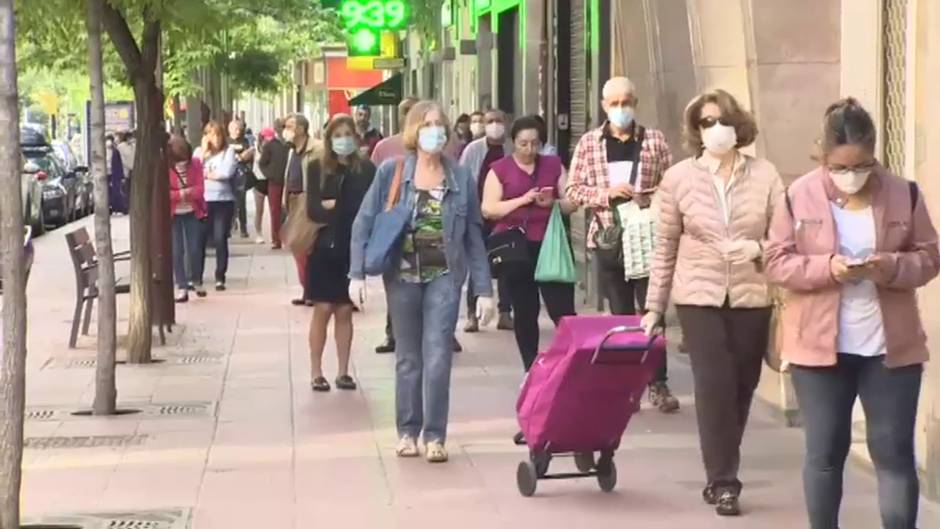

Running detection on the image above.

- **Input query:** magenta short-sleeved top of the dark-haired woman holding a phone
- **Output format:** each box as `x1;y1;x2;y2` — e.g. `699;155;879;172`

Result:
490;155;562;241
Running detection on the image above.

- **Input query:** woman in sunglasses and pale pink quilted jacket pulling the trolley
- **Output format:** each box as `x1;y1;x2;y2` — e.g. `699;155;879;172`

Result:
643;90;783;516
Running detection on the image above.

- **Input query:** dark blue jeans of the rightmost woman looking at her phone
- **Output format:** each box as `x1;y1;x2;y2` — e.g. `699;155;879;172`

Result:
792;354;923;529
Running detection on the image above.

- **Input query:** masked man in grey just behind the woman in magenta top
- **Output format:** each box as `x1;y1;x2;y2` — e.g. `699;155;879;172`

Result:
460;108;513;332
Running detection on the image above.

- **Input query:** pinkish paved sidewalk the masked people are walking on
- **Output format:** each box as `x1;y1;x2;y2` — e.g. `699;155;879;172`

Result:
14;219;940;529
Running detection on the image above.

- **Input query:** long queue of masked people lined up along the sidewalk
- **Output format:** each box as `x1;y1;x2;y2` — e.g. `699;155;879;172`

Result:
167;88;940;529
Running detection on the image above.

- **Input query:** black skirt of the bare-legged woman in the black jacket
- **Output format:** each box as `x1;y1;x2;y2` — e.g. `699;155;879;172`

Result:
307;233;352;304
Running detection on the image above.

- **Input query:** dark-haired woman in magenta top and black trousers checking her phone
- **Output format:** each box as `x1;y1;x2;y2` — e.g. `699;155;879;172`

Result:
483;117;577;444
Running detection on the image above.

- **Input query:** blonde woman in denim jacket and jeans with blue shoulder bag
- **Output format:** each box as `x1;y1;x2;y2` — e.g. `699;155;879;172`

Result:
349;101;495;463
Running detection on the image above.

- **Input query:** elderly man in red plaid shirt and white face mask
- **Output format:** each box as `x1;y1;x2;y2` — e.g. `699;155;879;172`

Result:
566;77;679;413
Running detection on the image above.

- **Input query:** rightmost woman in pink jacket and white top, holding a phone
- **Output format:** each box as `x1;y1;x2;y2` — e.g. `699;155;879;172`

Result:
765;98;940;529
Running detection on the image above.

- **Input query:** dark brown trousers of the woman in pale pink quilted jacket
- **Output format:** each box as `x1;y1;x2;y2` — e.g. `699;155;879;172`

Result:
676;305;770;491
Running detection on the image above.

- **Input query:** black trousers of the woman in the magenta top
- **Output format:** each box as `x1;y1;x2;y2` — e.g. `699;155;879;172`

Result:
501;241;575;372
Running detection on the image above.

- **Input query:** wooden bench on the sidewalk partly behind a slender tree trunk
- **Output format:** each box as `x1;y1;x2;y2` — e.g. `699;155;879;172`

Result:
65;228;131;349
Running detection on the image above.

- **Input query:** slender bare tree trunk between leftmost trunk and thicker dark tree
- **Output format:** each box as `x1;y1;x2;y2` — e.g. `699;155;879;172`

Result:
85;0;117;415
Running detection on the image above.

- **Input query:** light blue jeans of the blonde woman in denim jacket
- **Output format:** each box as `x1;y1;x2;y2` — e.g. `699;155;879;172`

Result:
385;274;460;443
